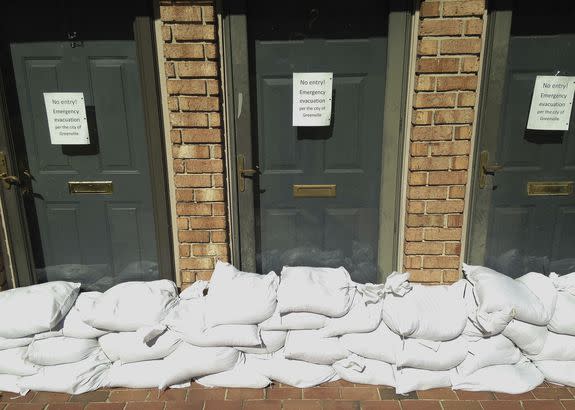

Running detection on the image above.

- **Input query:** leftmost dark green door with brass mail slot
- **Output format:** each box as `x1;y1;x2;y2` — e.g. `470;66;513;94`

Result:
5;2;160;289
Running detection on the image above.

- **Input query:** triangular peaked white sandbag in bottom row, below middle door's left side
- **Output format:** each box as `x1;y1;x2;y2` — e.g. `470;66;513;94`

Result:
195;360;271;389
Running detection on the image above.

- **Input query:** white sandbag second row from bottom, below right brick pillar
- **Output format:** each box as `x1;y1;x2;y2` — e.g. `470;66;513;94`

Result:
396;336;468;370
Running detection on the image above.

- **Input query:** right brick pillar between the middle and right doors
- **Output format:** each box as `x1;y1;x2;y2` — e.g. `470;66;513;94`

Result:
404;0;485;283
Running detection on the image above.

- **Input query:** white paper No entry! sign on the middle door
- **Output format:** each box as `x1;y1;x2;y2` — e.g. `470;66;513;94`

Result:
292;73;333;127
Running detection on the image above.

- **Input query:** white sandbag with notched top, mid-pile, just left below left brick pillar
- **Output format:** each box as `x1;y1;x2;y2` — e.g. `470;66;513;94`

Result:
98;330;181;363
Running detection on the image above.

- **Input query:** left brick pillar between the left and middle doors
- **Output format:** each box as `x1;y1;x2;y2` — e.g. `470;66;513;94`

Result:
160;0;229;287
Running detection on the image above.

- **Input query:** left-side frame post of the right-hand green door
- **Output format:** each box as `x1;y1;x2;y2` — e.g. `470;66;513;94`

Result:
464;0;513;265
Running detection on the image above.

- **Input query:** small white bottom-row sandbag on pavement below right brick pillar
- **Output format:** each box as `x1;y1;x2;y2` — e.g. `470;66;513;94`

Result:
394;367;453;394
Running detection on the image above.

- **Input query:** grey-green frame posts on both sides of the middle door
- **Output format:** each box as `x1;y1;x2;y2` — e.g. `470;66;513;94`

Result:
217;0;415;281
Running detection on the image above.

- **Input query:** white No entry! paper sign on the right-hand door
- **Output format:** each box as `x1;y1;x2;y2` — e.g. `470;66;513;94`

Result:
527;75;575;131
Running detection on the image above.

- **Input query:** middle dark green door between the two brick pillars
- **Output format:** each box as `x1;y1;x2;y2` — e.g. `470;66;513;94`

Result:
248;1;389;282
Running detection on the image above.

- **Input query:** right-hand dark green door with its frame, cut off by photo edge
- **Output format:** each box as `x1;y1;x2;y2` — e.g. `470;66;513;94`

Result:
468;1;575;277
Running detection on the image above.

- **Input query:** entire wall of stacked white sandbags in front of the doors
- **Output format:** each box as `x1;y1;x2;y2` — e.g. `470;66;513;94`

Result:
0;262;575;394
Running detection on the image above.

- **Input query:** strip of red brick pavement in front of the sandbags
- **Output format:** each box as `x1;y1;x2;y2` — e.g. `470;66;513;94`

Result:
0;381;575;410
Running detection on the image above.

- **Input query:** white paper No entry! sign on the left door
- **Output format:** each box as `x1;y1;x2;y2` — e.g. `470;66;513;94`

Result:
44;93;90;145
